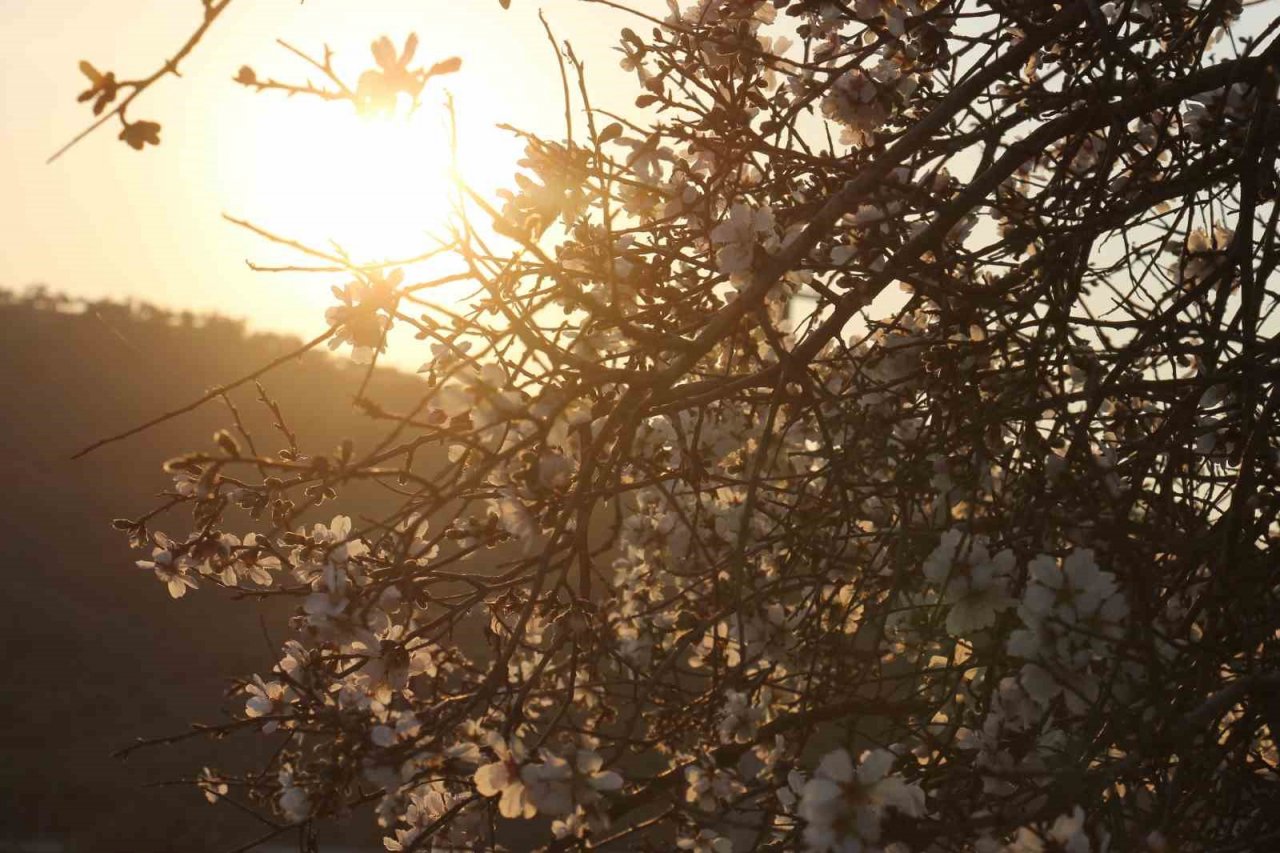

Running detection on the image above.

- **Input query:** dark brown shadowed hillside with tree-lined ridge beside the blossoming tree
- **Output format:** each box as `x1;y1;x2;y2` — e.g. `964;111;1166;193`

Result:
0;288;435;852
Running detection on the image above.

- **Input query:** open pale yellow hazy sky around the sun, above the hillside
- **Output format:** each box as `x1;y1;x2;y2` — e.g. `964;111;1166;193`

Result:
0;0;635;336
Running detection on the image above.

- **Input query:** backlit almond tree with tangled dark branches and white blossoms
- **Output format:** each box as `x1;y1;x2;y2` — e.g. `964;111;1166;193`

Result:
70;0;1280;853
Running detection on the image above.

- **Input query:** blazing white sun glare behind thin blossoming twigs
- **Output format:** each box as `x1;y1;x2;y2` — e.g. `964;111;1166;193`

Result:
207;56;524;368
